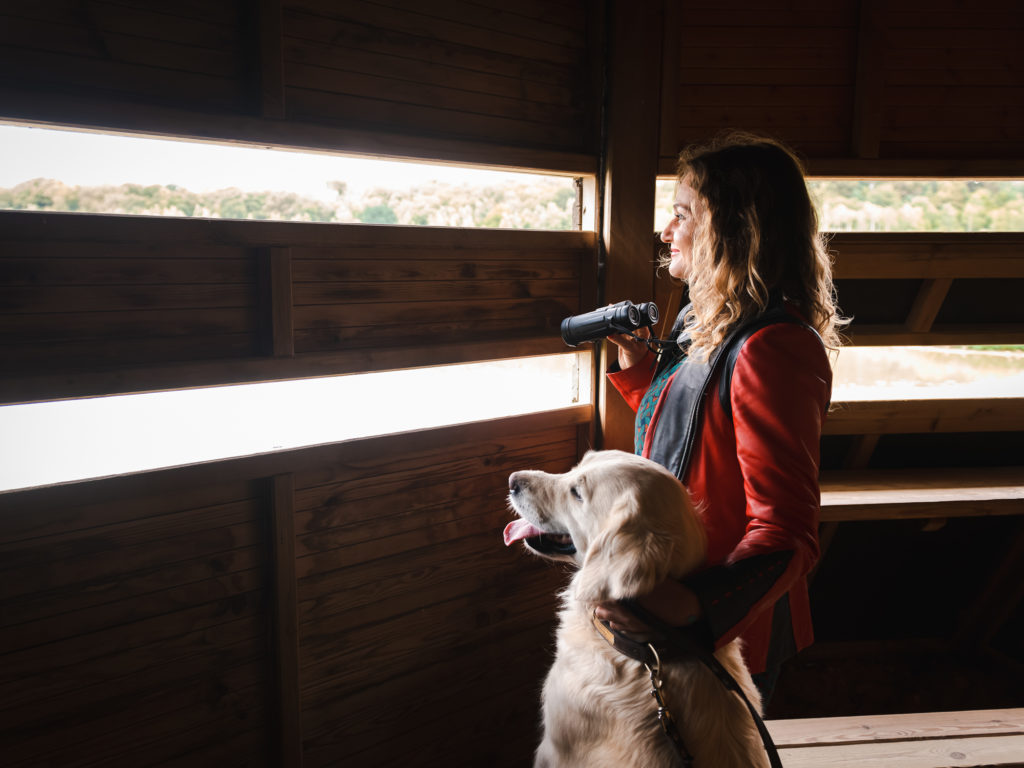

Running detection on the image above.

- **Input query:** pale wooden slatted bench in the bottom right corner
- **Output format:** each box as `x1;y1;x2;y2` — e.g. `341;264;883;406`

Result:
768;709;1024;768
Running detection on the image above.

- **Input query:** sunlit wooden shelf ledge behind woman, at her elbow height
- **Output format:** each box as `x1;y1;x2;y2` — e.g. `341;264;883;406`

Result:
820;467;1024;522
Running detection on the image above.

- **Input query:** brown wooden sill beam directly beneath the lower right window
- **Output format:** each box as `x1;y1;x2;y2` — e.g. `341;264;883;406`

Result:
821;397;1024;434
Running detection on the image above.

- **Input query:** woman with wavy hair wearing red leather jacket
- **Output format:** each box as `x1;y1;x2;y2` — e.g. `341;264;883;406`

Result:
595;134;842;699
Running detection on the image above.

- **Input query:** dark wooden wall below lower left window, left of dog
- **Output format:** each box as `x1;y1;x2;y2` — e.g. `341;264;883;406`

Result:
0;407;593;766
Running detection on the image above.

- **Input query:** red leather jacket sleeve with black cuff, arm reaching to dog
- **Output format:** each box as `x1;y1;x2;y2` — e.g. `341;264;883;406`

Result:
687;324;831;647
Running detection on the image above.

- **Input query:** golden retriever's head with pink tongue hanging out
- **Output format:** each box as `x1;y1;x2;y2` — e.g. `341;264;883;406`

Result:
505;451;705;602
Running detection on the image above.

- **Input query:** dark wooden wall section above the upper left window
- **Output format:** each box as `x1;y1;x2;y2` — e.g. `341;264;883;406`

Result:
0;0;603;168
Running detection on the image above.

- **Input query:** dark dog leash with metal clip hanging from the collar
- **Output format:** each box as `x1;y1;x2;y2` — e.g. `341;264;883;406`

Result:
594;600;782;768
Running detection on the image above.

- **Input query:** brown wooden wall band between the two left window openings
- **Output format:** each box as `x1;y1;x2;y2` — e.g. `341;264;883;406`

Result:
0;212;596;402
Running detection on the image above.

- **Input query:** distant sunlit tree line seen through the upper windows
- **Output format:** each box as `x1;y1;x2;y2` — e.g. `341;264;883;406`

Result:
0;178;1024;231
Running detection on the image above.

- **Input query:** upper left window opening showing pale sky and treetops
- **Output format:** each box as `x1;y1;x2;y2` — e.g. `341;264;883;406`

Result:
0;124;577;229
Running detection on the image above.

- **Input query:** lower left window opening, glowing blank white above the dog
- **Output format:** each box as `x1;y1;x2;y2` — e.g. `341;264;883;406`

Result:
0;352;593;492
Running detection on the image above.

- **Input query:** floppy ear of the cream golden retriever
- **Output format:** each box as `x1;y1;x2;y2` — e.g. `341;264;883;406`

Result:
572;489;673;603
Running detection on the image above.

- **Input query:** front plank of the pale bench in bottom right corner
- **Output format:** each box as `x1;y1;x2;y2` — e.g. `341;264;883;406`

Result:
779;734;1024;768
